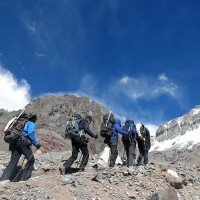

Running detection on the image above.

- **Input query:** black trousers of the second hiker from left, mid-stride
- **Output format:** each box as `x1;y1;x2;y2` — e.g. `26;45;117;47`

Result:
63;139;89;170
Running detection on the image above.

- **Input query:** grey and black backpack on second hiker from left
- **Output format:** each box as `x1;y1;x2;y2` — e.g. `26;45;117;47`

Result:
65;113;83;139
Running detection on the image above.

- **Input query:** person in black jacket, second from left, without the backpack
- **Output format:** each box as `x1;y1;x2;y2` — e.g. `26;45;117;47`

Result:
59;115;98;174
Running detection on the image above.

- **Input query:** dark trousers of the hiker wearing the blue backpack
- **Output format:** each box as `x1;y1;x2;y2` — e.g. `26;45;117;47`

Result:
122;140;136;167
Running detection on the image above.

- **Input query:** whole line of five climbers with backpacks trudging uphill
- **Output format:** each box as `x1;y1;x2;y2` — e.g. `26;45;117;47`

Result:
0;110;151;181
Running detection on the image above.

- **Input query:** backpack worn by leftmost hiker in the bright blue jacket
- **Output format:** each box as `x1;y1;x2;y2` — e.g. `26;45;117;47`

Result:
4;110;28;144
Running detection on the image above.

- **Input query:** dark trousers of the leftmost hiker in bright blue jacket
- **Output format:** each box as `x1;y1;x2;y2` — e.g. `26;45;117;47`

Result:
0;139;35;181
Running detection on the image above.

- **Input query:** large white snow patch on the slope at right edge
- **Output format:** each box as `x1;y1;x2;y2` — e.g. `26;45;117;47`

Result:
150;127;200;152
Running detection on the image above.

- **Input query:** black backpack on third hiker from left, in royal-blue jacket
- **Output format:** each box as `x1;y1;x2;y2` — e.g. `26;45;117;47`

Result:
100;112;115;138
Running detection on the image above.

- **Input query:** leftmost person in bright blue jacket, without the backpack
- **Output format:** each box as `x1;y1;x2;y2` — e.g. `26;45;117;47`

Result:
0;113;41;181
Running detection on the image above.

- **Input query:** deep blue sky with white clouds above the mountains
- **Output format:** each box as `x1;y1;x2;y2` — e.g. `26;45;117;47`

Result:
0;0;200;134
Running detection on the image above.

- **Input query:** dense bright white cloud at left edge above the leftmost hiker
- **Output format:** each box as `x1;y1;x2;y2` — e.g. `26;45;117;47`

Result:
0;64;30;111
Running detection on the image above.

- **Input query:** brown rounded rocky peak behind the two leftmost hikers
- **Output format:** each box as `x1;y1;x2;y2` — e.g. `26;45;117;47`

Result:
0;94;106;152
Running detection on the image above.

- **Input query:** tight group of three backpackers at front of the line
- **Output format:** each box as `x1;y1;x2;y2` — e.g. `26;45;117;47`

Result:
100;112;151;168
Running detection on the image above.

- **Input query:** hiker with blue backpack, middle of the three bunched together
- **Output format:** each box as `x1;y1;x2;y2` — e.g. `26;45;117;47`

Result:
122;119;136;167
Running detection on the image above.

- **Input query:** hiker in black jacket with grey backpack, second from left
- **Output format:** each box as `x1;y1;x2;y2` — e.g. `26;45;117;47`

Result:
59;114;98;175
